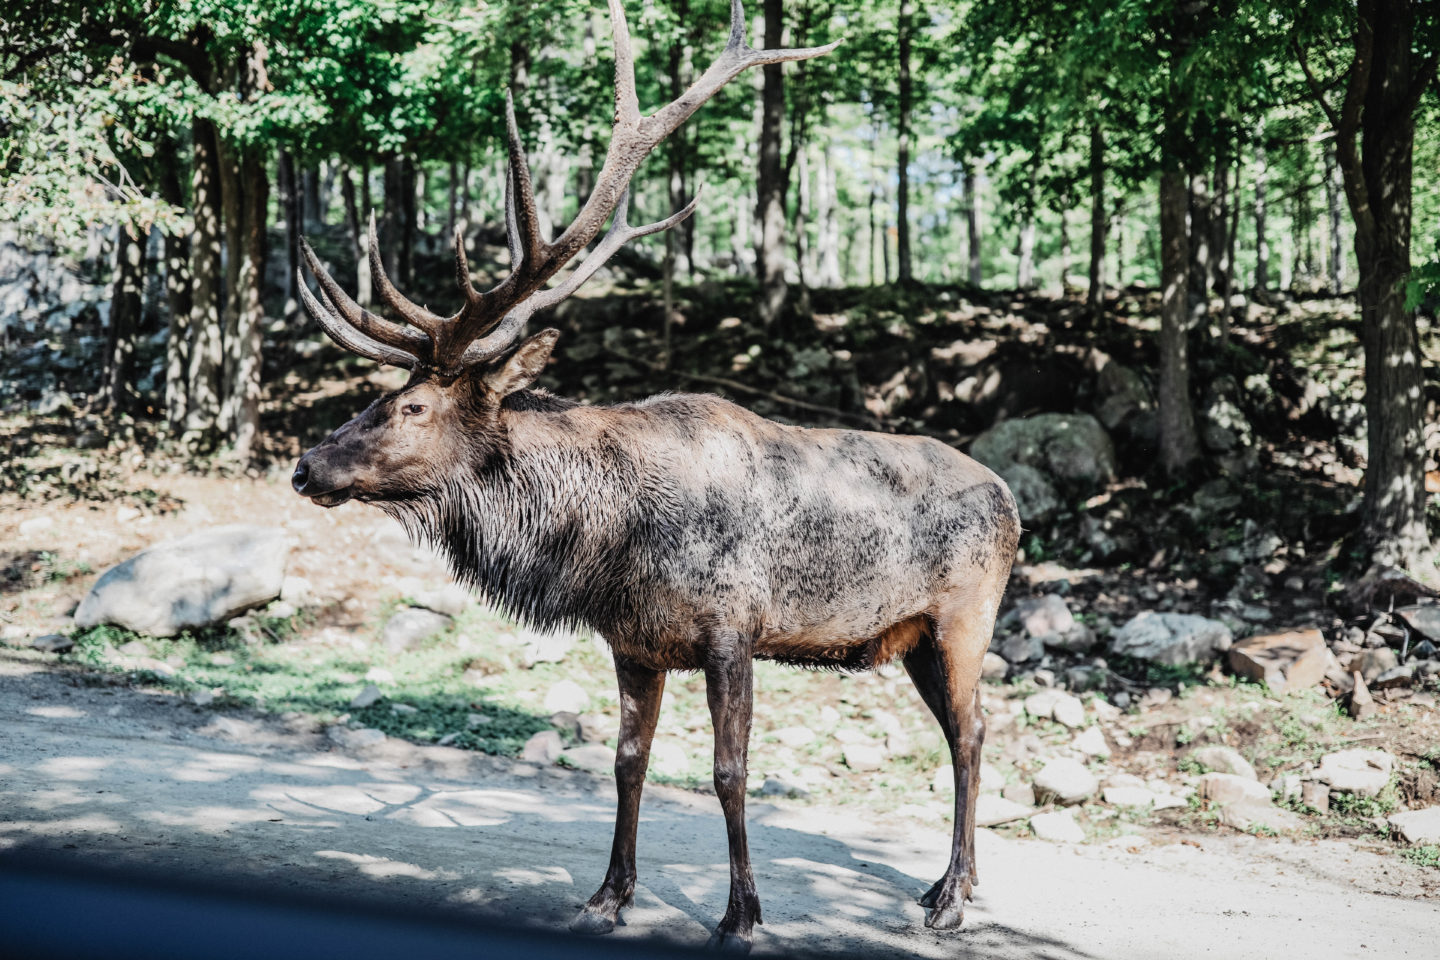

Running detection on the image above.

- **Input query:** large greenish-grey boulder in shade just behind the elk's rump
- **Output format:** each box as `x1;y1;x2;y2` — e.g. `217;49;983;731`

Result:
971;413;1115;489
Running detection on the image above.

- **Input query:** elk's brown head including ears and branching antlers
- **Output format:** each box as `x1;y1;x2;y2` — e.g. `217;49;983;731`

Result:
291;0;837;507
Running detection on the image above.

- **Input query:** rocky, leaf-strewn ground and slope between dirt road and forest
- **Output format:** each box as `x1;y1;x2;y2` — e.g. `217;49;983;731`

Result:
0;250;1440;938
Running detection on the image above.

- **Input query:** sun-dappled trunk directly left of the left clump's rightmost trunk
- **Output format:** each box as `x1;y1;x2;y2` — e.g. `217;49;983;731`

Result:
184;119;225;449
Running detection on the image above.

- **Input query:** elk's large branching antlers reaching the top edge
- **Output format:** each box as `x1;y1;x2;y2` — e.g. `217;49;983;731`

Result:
301;0;838;376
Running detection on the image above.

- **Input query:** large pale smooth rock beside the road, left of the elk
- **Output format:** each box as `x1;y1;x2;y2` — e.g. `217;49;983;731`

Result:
75;525;289;636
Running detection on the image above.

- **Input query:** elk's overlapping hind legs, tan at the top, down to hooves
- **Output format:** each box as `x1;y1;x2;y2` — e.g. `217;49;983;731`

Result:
904;606;995;930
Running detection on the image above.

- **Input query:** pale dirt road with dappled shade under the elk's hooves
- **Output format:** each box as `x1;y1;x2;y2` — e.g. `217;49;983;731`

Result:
0;652;1436;960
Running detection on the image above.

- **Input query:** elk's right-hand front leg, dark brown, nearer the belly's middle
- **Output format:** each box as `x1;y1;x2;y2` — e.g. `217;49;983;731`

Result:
706;633;763;953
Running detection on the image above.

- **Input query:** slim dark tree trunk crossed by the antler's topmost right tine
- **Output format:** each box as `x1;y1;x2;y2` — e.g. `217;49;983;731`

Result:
755;0;789;327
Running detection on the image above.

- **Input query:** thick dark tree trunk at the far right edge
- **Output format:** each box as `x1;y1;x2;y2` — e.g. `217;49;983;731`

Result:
1332;0;1436;577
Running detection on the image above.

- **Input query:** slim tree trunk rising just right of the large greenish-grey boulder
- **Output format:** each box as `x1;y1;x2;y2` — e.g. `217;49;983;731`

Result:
1159;168;1200;476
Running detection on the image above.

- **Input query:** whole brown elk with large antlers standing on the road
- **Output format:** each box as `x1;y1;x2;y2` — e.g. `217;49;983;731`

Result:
292;0;1020;951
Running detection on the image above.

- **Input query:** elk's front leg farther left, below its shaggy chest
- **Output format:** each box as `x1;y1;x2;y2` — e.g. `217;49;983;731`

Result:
570;656;665;934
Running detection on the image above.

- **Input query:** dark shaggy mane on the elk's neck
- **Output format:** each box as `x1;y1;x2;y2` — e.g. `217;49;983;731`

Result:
376;390;648;632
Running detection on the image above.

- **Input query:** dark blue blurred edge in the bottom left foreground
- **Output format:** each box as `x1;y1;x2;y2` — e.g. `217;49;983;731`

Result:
0;856;693;960
